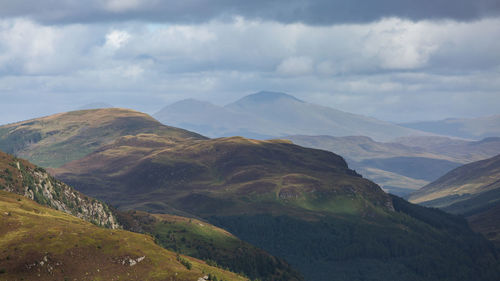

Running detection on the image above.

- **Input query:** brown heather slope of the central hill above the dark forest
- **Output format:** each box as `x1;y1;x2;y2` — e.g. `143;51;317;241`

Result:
52;134;391;217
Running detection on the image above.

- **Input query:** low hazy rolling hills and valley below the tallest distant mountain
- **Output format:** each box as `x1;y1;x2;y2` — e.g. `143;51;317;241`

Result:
286;135;500;196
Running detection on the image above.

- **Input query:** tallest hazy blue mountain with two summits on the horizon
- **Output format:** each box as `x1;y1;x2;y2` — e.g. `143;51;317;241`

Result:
154;92;422;140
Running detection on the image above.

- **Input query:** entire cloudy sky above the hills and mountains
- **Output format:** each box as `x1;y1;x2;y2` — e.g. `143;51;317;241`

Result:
0;0;500;124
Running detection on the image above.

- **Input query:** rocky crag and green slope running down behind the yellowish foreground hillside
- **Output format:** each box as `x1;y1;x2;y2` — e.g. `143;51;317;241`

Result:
0;148;294;280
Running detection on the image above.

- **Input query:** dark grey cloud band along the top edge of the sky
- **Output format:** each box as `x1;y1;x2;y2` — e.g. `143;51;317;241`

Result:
0;0;500;25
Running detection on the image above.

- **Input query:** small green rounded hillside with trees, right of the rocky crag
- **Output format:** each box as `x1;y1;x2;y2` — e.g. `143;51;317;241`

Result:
120;211;303;281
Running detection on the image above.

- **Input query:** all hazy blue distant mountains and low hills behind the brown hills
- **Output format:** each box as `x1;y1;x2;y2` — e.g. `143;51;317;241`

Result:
153;91;500;196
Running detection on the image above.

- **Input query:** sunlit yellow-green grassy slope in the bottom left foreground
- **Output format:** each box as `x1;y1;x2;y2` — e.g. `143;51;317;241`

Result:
0;191;247;280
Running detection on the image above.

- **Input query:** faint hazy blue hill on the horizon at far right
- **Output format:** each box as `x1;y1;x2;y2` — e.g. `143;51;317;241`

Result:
401;115;500;139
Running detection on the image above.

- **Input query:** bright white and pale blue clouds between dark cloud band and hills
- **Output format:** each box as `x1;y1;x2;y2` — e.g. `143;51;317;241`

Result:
0;18;500;123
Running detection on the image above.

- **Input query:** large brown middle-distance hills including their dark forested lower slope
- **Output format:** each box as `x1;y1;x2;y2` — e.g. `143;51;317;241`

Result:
0;106;500;280
